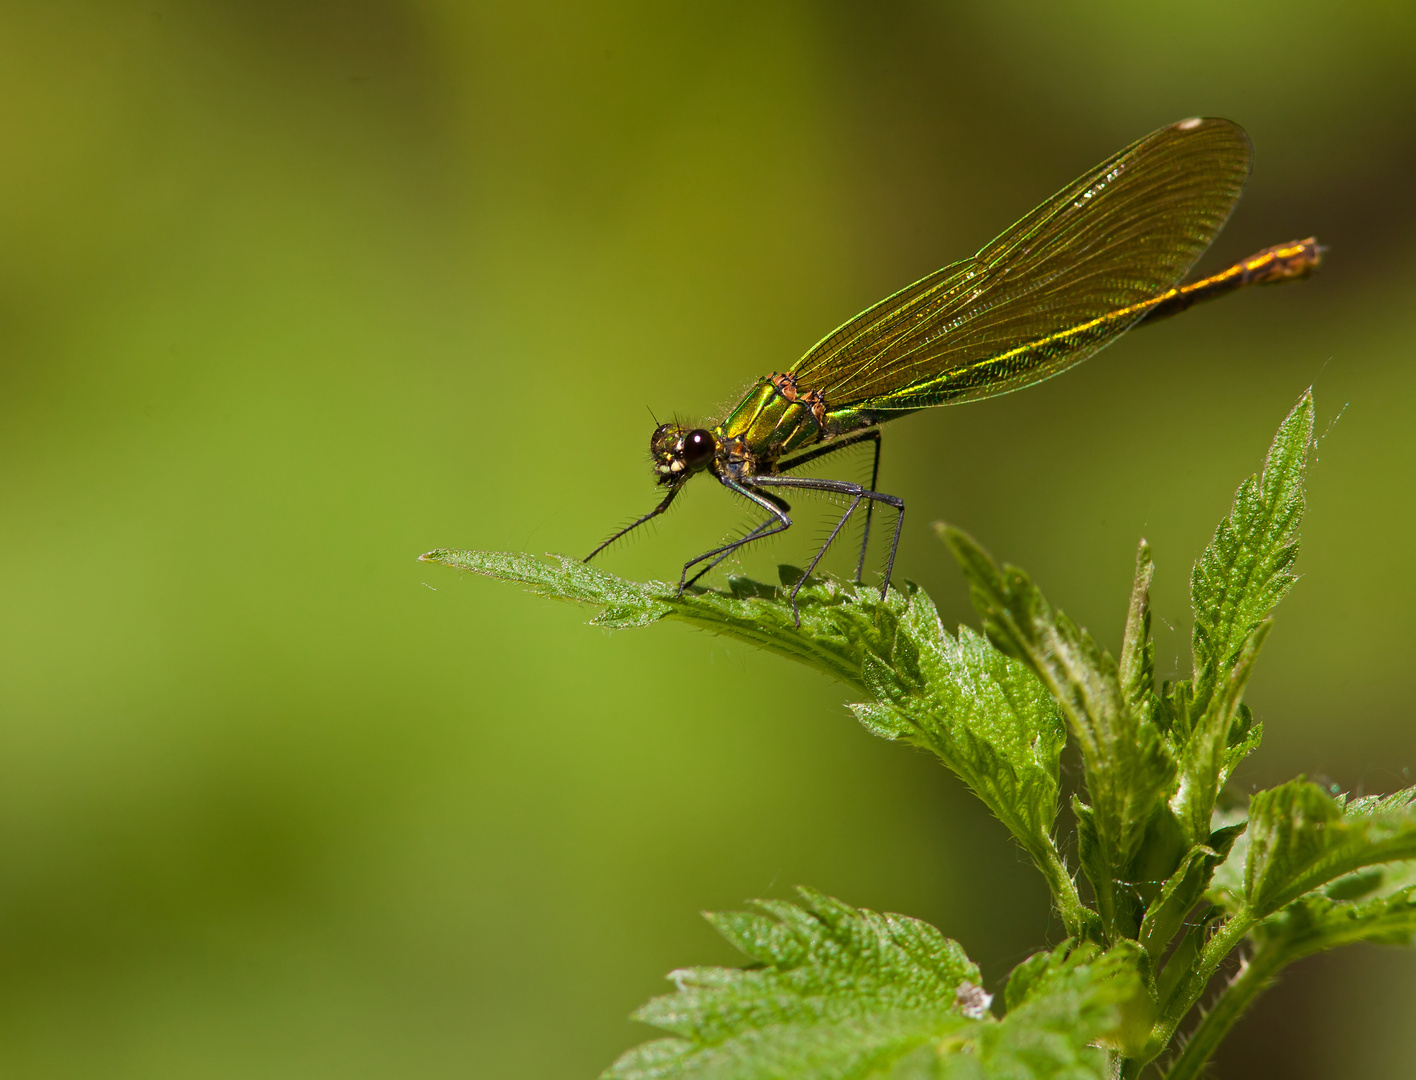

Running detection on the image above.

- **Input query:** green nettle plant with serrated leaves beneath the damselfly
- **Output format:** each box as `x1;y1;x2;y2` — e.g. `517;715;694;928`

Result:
422;393;1416;1080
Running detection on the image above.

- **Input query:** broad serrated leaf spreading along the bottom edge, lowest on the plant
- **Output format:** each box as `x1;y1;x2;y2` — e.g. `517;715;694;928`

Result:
603;889;1143;1080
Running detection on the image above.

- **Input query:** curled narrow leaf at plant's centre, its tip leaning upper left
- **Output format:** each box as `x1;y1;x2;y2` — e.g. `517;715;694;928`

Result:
937;525;1175;937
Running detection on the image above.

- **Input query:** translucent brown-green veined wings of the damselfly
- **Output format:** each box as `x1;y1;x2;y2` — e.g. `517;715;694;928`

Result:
794;119;1250;412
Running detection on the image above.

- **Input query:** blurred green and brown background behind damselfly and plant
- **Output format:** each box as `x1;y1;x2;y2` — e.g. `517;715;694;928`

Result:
0;0;1416;1079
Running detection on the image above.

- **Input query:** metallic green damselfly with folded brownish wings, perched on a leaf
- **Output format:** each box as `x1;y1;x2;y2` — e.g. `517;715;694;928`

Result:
586;117;1323;621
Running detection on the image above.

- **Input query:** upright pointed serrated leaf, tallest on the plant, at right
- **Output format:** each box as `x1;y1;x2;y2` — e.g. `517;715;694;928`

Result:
1189;389;1313;716
